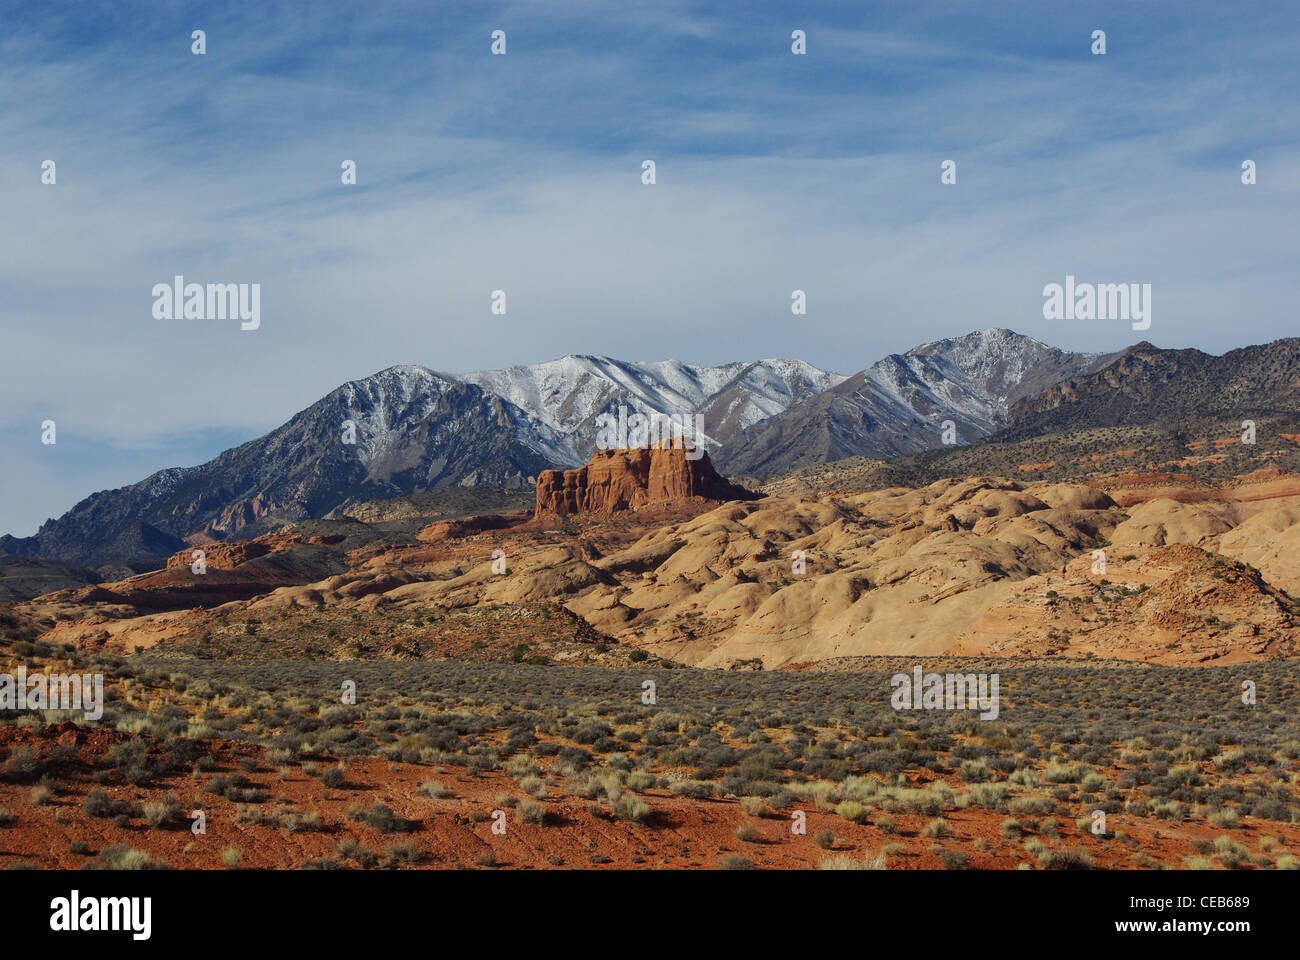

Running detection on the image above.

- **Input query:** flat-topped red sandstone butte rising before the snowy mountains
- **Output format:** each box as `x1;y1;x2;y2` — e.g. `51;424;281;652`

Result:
534;446;758;518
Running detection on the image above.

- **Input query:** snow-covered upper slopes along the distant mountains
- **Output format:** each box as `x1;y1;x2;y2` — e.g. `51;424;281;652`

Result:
348;328;1102;470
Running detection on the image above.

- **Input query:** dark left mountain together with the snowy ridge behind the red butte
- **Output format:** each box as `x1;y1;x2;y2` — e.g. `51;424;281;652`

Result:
0;356;842;563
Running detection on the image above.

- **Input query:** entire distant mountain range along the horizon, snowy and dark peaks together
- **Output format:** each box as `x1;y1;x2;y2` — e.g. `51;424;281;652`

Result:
0;329;1300;566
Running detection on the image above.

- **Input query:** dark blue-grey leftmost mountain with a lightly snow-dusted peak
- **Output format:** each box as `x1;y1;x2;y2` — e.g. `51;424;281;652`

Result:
0;367;556;565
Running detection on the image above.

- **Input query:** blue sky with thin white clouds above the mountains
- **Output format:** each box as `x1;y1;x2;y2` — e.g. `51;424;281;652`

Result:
0;0;1300;535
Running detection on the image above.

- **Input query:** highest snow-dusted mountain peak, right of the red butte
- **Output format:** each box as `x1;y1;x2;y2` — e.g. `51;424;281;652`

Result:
733;328;1115;475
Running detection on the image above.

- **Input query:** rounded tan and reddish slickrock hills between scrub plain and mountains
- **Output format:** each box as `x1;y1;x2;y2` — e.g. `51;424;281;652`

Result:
18;476;1300;669
